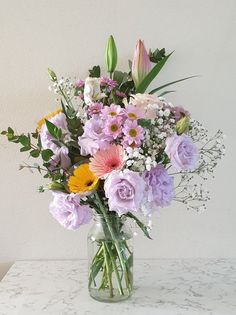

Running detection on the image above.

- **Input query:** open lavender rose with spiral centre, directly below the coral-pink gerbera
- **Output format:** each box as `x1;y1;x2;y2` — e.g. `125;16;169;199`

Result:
104;170;145;216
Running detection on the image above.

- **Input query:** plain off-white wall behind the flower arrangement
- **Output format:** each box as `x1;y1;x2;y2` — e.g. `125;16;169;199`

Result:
0;0;236;280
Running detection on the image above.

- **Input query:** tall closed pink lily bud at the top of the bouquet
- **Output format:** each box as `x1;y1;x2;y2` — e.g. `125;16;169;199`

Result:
132;40;151;87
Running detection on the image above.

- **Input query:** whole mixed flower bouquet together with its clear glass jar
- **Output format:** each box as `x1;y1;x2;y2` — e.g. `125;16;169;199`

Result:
2;36;225;301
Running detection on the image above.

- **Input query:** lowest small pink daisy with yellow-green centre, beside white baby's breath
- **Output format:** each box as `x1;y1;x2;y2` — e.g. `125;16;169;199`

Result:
123;120;144;147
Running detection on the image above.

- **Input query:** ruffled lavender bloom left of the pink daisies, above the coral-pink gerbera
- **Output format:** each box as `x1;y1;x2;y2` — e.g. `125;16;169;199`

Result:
78;116;112;155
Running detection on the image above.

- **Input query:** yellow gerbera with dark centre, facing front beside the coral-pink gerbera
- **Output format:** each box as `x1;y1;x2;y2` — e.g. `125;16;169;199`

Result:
67;164;98;194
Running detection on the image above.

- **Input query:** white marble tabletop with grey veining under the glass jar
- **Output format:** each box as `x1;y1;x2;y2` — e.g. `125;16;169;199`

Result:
0;259;236;315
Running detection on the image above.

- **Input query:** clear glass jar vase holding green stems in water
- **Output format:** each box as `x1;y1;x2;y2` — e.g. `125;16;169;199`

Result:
88;214;133;302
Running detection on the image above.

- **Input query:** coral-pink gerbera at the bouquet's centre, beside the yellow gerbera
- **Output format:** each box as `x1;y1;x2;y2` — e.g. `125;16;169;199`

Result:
89;144;123;178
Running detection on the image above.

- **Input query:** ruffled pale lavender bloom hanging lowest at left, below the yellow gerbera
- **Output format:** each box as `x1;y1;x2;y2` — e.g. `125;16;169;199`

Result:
49;192;92;230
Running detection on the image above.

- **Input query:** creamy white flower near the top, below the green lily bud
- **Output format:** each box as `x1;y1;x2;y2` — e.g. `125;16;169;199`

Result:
84;77;106;105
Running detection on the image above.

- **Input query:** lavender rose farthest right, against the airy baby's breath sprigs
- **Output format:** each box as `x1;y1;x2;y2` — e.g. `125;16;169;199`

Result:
165;134;199;171
